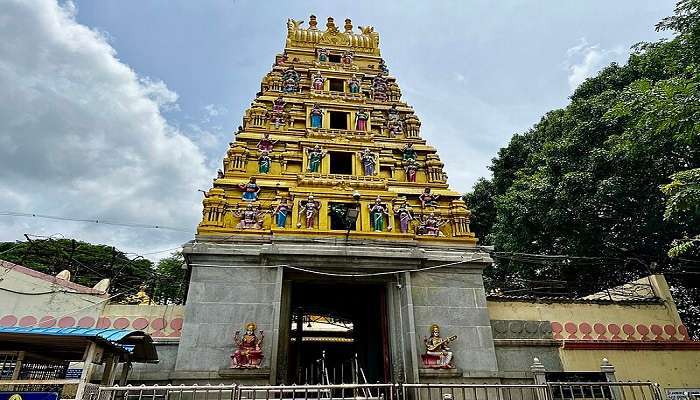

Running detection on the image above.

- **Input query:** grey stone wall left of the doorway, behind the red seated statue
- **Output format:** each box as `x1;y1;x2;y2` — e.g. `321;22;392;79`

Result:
175;264;279;371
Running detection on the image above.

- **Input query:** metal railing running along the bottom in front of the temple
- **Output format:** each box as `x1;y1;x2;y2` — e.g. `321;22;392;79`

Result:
91;382;664;400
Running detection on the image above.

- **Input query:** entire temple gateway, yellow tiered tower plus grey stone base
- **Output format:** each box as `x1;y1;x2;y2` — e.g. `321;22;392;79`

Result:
180;16;497;383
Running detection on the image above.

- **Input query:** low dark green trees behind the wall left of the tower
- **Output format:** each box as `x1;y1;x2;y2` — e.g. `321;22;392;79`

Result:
0;238;186;303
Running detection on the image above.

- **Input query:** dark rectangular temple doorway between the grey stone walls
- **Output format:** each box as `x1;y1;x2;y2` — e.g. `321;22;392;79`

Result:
287;282;391;384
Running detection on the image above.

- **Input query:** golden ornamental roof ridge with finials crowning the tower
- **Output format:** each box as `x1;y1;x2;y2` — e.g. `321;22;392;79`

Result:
286;15;379;56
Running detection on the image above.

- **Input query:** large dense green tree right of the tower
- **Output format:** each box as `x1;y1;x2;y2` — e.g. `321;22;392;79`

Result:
465;0;700;334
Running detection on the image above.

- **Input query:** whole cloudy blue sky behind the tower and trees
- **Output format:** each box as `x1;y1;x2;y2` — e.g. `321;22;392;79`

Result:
0;0;674;259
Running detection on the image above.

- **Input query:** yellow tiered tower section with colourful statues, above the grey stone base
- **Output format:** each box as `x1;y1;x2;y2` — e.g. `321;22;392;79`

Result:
198;16;476;244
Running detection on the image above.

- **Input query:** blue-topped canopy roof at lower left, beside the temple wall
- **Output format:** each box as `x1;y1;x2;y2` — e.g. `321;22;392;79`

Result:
0;326;158;363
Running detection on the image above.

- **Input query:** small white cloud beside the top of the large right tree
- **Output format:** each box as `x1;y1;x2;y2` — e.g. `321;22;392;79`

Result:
564;37;627;92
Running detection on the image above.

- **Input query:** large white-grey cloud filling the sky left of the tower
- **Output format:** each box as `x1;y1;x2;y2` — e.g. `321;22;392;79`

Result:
0;0;211;252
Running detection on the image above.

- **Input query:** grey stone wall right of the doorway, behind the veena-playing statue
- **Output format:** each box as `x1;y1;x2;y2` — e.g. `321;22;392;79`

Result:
411;269;497;371
